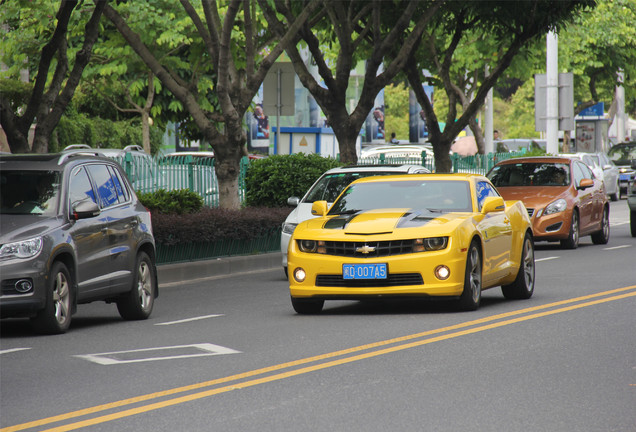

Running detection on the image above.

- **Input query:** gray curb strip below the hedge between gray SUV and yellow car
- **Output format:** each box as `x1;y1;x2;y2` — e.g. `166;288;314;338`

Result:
157;252;283;286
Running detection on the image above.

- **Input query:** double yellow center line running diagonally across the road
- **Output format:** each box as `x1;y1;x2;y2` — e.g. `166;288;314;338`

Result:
6;285;636;432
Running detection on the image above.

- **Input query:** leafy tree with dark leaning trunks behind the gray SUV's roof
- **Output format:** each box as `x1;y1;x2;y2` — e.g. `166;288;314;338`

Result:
0;0;106;153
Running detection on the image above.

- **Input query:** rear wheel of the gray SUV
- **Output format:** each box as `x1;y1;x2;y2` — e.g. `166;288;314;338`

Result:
117;252;157;320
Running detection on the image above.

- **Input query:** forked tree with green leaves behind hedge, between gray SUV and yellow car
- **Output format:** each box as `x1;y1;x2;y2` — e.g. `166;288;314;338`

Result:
104;0;319;209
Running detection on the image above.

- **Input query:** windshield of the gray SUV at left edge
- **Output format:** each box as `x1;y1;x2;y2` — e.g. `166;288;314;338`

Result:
0;170;60;216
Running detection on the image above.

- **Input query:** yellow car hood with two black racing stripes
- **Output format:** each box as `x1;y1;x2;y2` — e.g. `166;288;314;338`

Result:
299;209;467;237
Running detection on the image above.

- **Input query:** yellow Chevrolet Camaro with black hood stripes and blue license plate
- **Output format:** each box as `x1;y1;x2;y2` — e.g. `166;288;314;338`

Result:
288;174;535;314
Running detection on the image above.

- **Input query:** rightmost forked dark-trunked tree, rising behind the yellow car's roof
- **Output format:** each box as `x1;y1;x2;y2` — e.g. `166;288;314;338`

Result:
405;0;594;172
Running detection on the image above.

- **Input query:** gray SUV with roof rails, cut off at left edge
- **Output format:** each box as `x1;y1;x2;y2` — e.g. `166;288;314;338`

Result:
0;153;158;334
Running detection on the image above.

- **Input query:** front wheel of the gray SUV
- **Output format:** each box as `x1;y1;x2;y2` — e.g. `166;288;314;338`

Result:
31;261;73;334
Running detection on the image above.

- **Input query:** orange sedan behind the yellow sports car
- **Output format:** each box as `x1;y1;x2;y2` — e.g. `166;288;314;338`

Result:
487;156;610;249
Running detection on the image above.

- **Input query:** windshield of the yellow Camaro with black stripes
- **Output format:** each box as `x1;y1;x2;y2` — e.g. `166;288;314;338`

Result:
329;180;472;215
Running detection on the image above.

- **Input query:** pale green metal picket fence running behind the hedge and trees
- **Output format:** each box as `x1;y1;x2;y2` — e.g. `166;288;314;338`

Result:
114;151;523;207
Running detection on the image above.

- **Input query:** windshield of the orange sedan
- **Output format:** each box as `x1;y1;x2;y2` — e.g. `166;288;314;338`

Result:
488;162;570;187
